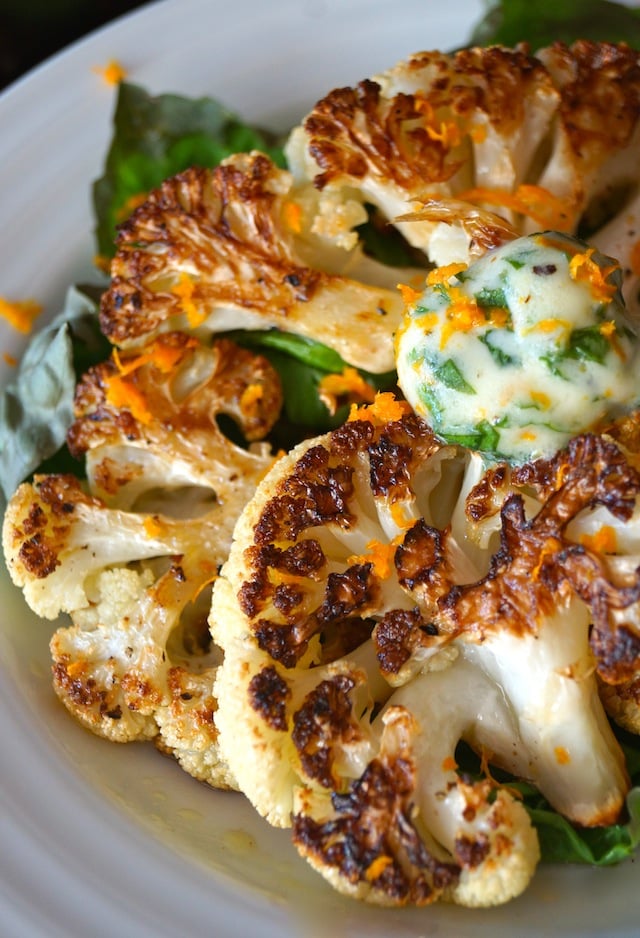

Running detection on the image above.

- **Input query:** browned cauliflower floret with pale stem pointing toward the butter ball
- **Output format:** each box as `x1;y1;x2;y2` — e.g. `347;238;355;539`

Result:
101;153;412;372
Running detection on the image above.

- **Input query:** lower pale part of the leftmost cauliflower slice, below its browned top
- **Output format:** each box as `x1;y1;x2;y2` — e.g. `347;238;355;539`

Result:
3;476;231;787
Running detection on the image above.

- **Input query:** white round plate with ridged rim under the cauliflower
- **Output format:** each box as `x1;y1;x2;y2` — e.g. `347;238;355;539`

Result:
0;0;640;938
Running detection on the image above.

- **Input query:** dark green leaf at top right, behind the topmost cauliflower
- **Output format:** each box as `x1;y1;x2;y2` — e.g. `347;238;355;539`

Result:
468;0;640;49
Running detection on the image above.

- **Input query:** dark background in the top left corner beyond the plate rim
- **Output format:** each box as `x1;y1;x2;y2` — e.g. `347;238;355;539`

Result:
0;0;148;88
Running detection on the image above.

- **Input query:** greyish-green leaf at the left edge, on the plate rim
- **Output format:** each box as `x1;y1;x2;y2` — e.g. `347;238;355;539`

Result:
0;287;109;498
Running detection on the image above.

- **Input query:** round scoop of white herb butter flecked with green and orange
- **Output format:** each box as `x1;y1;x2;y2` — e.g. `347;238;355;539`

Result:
396;232;640;462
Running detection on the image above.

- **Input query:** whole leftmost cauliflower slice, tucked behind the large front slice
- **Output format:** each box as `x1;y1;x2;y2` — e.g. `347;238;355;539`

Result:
3;334;281;787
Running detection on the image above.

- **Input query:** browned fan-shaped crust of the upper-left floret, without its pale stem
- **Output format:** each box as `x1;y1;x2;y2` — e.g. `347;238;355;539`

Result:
100;154;323;345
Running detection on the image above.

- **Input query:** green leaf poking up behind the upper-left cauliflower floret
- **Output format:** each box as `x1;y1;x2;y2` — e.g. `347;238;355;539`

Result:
93;82;284;257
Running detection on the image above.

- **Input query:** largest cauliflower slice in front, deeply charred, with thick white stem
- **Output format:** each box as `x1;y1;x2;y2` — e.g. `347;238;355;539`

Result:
212;395;640;906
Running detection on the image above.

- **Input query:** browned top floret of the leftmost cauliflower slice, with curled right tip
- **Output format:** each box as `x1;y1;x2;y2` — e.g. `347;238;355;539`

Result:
67;333;282;512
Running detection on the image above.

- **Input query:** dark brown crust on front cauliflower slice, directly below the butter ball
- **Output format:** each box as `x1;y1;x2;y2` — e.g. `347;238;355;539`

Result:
440;434;640;660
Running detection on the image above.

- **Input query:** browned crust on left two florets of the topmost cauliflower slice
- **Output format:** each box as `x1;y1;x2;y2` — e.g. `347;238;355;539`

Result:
304;46;550;197
